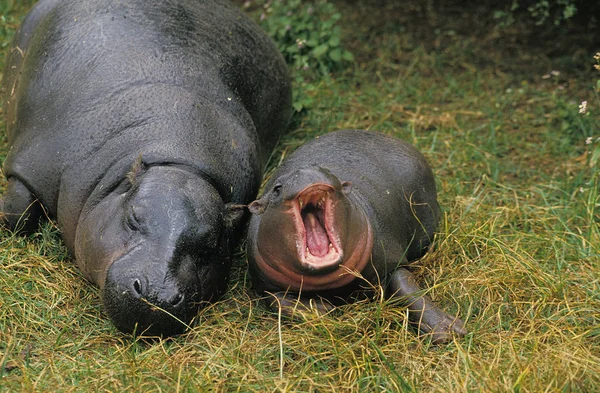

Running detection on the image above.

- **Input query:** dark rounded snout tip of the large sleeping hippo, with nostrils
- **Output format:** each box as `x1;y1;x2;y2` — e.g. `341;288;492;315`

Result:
103;254;199;336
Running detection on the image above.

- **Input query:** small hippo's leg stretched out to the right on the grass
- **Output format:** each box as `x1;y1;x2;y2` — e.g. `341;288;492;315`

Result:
389;268;468;344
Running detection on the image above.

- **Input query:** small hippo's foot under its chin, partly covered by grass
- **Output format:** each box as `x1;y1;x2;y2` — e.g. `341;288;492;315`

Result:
266;292;335;318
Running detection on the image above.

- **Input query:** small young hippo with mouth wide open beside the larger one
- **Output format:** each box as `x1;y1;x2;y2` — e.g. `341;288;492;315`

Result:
247;130;466;342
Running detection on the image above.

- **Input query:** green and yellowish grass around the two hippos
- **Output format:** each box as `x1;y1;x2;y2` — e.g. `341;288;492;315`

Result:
0;1;600;392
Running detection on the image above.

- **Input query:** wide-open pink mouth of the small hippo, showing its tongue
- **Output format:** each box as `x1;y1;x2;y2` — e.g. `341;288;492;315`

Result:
293;184;343;273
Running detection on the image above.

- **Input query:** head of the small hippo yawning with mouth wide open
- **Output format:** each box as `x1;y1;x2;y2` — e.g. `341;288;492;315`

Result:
248;167;373;291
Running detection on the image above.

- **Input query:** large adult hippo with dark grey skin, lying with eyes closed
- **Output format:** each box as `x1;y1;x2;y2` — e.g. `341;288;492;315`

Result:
0;0;291;335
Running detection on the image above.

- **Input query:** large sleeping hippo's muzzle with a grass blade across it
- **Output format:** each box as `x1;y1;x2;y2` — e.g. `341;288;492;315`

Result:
102;245;209;335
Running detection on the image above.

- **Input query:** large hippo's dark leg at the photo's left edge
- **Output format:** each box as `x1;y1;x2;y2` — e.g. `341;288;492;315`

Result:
0;177;44;233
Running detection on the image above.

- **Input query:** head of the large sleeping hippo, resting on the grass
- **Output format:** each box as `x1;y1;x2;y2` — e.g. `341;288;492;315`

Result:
74;165;243;335
